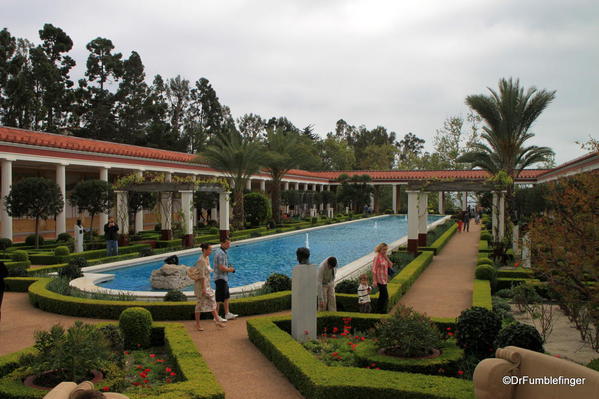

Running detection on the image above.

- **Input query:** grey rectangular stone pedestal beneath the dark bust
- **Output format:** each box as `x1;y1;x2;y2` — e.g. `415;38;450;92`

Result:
291;264;318;342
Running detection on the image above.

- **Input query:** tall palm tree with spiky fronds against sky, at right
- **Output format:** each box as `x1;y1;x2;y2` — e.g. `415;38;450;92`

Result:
458;78;555;234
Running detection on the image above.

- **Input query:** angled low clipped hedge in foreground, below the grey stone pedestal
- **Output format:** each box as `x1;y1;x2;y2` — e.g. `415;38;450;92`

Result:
247;316;474;399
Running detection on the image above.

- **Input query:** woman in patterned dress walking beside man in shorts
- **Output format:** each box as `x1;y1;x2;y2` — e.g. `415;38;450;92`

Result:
187;244;227;331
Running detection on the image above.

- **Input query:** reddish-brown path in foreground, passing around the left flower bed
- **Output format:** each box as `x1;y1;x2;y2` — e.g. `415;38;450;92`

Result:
0;292;302;399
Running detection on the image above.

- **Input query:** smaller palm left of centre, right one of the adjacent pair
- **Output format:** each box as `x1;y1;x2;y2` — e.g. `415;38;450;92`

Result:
263;128;307;224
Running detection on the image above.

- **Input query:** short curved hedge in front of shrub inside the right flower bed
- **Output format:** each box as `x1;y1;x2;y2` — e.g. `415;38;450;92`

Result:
355;340;464;376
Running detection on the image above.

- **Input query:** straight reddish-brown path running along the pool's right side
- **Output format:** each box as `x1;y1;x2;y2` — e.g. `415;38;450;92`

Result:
399;222;480;317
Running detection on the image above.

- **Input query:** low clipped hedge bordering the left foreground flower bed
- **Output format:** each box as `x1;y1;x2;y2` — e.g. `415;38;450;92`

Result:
0;323;225;399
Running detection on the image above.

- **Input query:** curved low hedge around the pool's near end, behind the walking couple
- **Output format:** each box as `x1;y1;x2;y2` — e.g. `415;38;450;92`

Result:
29;278;291;320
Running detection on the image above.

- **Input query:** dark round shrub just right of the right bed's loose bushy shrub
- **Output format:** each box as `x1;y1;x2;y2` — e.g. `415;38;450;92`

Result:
455;306;501;357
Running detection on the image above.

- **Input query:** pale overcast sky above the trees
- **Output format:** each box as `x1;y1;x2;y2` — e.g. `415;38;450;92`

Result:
0;0;599;163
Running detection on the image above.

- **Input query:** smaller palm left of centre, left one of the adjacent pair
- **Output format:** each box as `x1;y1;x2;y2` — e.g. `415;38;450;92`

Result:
198;129;262;228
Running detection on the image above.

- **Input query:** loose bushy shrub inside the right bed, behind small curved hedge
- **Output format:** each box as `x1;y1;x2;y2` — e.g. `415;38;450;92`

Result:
374;305;441;357
